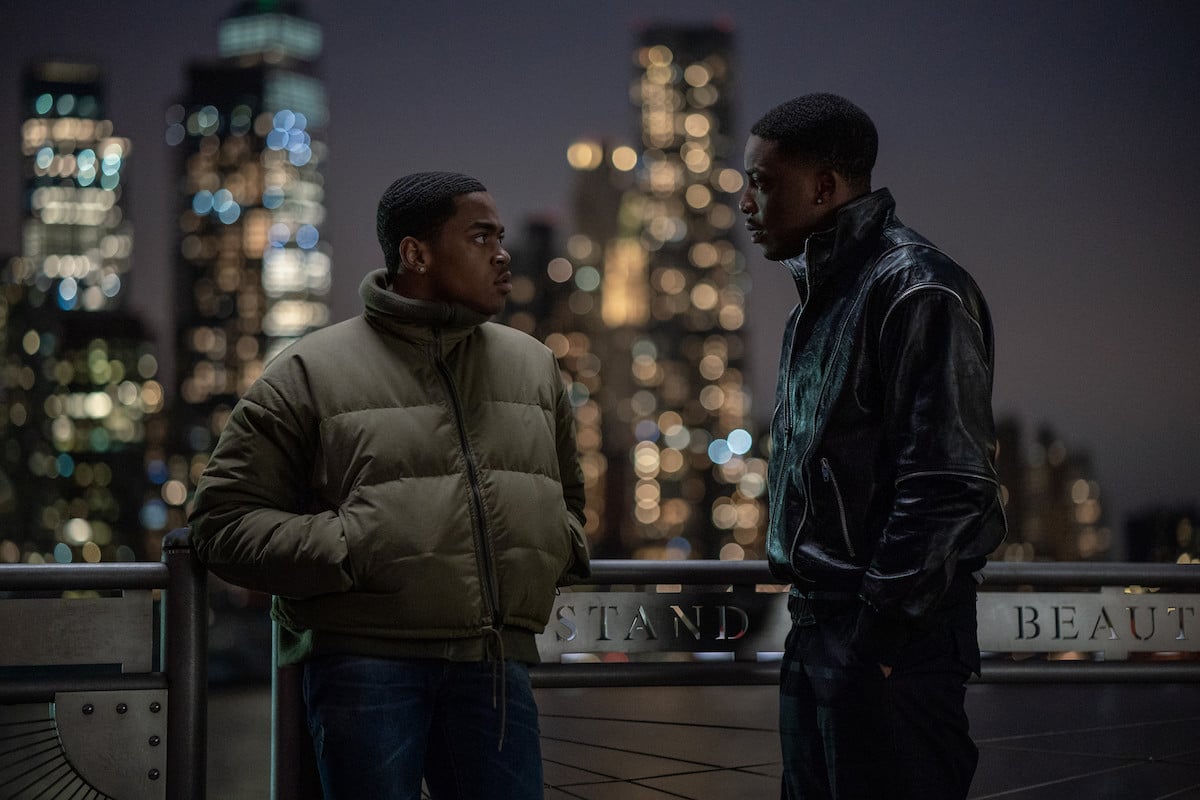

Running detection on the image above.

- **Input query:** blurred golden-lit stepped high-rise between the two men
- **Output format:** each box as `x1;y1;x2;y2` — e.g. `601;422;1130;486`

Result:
499;25;766;559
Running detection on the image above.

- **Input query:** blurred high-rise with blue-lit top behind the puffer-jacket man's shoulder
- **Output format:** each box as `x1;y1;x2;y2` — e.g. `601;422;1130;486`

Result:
166;0;331;532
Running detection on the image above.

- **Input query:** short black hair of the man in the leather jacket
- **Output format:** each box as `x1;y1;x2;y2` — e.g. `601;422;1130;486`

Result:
750;92;880;188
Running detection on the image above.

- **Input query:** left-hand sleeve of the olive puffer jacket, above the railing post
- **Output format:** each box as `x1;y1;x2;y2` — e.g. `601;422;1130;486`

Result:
188;365;352;597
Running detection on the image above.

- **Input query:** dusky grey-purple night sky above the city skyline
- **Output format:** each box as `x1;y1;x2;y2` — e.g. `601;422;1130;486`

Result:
0;0;1200;542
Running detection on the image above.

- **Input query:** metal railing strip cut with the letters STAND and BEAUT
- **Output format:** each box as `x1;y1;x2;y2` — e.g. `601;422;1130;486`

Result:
538;588;1200;661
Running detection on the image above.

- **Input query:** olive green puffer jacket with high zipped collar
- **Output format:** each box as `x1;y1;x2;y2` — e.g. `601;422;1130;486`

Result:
190;270;588;663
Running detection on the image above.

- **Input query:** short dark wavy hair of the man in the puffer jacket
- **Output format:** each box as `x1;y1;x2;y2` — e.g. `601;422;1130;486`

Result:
376;172;487;281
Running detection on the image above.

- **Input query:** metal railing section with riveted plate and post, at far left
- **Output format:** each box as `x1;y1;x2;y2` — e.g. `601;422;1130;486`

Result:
0;529;208;800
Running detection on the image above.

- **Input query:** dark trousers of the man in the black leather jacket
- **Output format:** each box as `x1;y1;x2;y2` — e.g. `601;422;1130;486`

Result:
779;585;979;800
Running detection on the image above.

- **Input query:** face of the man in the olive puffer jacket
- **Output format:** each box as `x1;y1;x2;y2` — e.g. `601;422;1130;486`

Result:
427;192;512;315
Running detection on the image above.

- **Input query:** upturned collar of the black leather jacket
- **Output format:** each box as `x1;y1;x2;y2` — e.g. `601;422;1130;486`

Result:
782;188;896;300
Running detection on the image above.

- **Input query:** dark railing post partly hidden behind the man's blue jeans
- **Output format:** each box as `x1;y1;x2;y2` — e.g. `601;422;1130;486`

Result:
271;620;322;800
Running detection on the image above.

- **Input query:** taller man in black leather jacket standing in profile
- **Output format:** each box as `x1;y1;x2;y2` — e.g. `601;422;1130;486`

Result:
740;94;1006;800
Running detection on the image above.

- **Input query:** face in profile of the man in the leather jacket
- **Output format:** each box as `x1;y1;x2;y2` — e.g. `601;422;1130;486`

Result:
738;136;834;261
